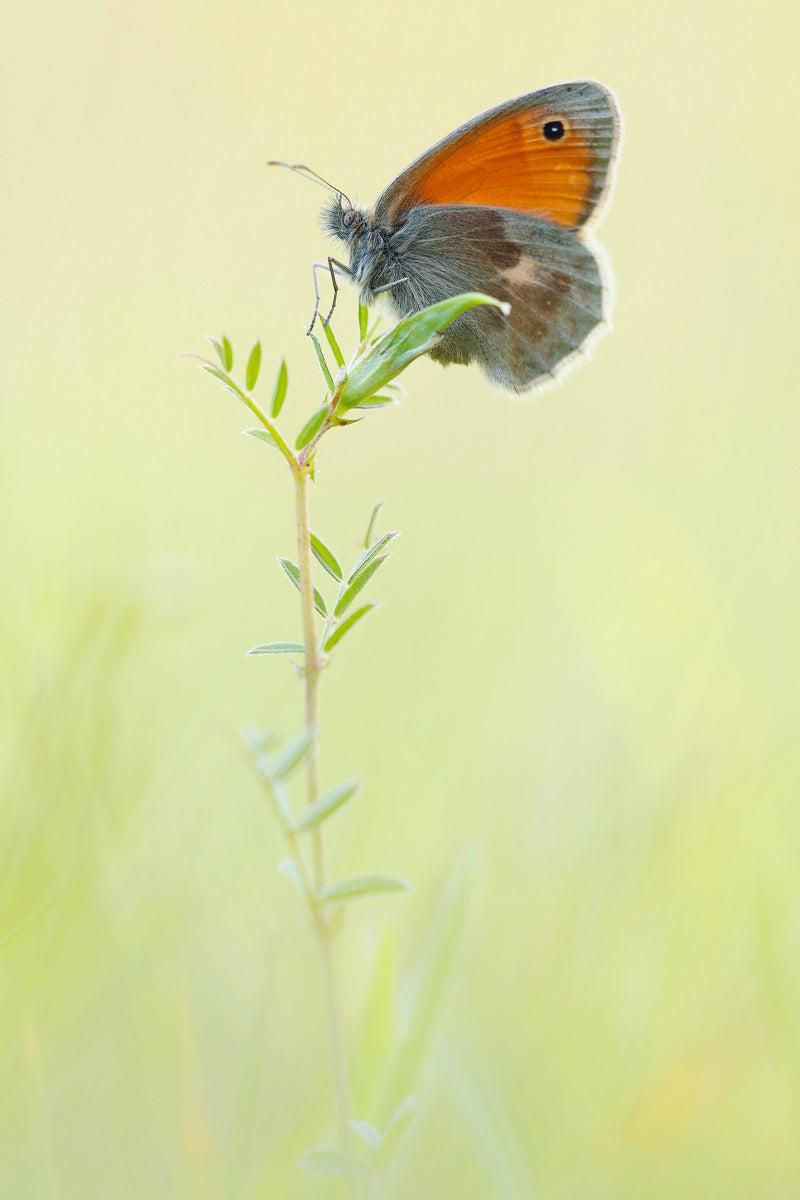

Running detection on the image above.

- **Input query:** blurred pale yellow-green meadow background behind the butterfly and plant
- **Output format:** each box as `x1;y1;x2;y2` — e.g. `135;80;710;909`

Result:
0;0;800;1200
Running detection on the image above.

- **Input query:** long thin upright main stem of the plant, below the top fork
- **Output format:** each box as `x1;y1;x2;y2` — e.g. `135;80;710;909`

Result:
293;462;361;1200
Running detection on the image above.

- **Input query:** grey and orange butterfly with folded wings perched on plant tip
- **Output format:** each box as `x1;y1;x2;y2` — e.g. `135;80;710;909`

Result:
318;80;621;392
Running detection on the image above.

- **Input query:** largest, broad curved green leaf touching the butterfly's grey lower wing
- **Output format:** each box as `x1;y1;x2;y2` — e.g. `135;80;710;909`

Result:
338;292;509;412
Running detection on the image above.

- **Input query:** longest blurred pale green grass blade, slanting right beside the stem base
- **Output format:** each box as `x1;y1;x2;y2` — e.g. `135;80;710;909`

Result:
378;850;475;1128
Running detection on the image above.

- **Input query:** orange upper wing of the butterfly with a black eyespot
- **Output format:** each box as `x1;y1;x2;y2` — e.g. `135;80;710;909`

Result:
375;82;620;229
